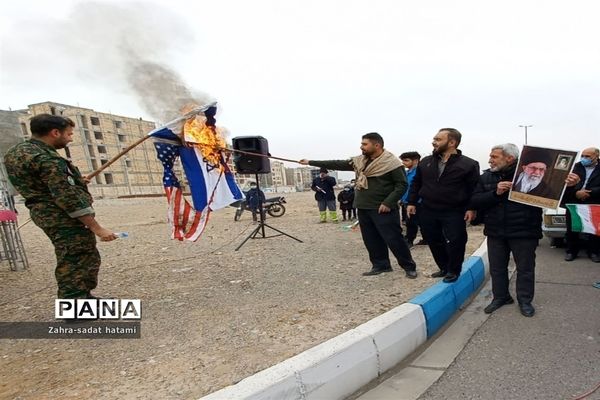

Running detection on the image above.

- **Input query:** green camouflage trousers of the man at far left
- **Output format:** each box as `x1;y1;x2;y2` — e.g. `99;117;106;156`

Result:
42;225;100;299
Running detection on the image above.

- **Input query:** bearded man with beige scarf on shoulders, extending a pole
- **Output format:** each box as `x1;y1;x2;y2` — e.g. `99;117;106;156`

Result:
299;132;417;279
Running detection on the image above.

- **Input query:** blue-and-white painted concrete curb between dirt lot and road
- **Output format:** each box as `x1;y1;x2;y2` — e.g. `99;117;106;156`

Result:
202;241;489;400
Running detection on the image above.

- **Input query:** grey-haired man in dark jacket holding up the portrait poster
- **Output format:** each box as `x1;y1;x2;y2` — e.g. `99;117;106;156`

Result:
471;143;579;317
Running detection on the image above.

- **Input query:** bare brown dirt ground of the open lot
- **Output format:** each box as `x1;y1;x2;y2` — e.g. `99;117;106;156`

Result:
0;192;483;399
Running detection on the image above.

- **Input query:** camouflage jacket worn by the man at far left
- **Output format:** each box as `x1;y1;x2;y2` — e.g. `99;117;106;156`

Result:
4;139;94;227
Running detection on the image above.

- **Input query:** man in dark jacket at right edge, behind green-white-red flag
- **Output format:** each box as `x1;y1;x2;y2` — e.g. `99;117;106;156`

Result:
563;147;600;262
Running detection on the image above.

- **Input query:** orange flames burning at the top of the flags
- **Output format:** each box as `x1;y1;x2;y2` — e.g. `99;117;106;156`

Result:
183;115;226;168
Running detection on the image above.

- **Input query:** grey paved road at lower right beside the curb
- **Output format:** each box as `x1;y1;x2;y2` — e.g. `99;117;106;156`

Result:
419;241;600;400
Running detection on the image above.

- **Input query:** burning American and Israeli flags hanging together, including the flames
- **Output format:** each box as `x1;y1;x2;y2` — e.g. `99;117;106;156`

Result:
148;104;244;241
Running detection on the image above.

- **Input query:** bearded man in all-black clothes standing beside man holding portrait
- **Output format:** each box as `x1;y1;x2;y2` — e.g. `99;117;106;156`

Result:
406;128;479;283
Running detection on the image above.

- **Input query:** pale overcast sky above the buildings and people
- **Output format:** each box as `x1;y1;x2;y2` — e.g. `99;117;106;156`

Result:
0;0;600;177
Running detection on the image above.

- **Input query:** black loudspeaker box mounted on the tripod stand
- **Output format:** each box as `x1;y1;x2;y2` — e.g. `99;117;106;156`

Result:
231;136;271;174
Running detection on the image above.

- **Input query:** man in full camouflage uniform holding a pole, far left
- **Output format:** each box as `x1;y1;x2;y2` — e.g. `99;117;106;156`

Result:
5;114;117;299
